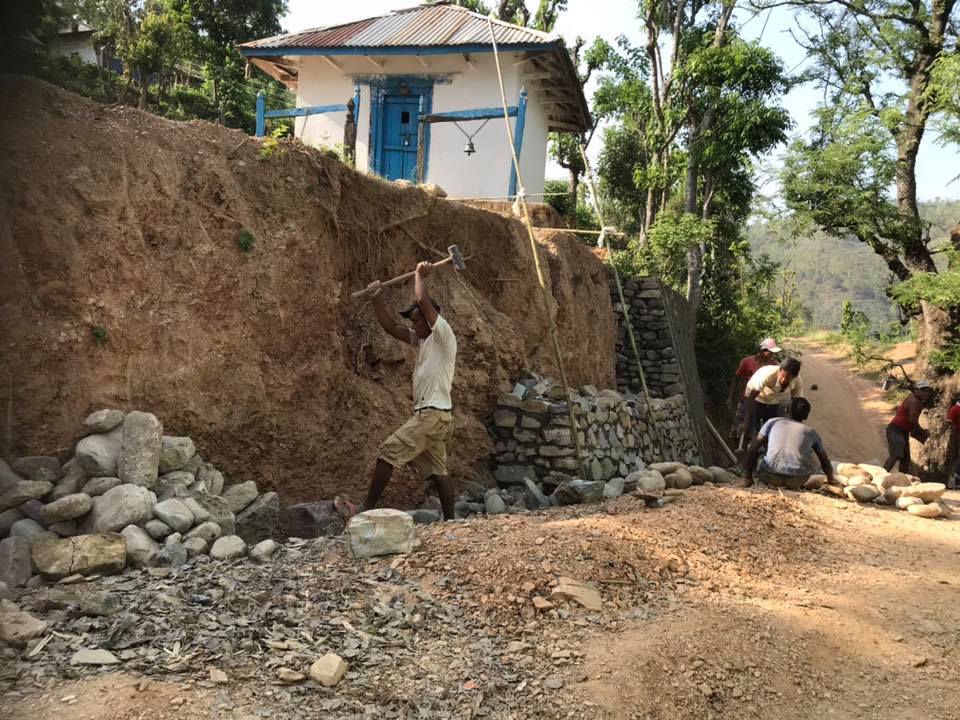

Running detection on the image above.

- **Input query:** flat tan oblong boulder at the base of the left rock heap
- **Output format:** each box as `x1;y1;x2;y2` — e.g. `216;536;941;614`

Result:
31;533;127;579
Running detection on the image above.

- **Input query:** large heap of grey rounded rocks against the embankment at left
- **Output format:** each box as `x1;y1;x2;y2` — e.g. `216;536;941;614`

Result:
0;410;280;587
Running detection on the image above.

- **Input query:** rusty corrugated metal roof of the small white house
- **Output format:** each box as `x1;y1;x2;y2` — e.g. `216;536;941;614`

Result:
240;5;556;49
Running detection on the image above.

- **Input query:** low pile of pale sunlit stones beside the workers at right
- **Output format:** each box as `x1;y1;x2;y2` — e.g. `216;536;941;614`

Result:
808;463;950;519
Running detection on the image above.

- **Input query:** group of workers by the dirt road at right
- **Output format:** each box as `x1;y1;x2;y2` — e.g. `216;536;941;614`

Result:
730;338;960;489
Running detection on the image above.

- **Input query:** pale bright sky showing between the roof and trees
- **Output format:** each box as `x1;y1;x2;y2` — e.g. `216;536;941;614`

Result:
283;0;960;201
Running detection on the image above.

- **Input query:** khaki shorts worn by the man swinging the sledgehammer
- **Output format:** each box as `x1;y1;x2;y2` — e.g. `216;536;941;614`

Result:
377;410;453;480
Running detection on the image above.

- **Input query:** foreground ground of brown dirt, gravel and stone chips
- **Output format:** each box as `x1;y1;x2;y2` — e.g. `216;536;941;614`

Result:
0;485;960;720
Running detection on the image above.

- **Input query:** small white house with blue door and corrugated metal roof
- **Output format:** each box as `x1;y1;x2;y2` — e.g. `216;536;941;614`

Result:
239;4;591;198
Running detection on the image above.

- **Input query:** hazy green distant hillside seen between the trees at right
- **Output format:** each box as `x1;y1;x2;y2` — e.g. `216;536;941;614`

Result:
747;200;960;329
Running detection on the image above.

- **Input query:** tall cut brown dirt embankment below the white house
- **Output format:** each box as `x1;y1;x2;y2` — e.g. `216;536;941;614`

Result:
0;76;614;504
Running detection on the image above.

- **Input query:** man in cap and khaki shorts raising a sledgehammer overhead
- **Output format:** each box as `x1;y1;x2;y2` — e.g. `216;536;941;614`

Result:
342;262;457;520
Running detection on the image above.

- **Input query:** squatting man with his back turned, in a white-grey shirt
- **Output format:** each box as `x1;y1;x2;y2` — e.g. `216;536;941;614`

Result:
743;398;833;490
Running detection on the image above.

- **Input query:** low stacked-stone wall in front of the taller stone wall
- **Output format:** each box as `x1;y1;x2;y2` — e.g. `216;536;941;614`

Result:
493;376;700;487
